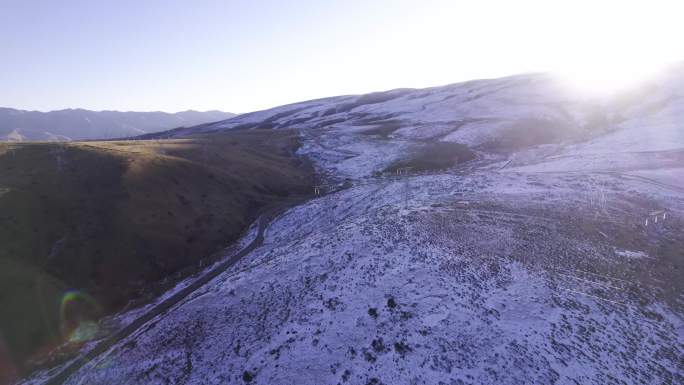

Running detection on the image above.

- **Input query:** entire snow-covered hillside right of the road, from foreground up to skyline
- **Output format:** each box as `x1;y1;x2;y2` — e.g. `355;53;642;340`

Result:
22;70;684;385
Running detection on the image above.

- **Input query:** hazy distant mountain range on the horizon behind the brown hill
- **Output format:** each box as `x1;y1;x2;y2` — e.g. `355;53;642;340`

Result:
0;108;235;141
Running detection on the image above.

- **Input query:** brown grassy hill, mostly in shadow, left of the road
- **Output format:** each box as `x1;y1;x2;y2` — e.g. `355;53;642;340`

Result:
0;130;312;372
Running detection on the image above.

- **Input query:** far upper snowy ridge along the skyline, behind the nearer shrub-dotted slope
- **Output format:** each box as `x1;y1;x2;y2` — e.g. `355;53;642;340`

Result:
173;67;684;179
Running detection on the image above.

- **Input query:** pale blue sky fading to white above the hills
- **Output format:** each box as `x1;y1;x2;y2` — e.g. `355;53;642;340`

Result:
0;0;684;112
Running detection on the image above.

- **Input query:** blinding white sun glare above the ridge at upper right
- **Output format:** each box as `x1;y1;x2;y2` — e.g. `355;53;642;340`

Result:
528;1;682;95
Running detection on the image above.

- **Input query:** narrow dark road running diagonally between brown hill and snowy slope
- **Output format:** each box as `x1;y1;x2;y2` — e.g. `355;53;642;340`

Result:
44;199;301;385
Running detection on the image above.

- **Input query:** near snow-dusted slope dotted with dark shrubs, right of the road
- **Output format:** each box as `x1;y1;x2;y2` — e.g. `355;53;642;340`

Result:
54;173;684;384
